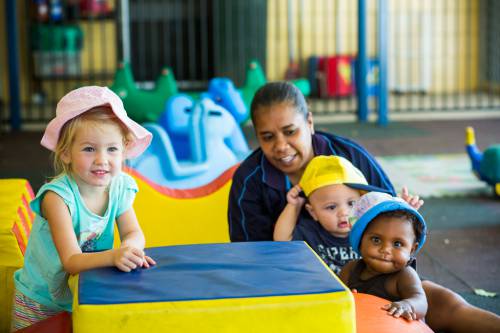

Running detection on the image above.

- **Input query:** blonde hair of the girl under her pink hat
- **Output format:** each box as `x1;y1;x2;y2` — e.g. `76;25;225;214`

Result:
53;106;134;177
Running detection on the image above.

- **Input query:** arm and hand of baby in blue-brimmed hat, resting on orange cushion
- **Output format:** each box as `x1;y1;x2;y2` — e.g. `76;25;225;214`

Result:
383;267;427;320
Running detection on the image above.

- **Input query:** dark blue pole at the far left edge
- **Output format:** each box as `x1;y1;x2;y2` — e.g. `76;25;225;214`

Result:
5;0;21;131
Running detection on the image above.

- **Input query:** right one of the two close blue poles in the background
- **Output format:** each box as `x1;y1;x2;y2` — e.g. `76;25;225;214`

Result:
377;0;389;126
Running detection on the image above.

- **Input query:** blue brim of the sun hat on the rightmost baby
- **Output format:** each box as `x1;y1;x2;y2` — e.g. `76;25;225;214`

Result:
349;201;427;255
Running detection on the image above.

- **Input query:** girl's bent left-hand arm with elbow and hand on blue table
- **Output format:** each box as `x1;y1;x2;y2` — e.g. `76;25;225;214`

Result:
41;191;149;274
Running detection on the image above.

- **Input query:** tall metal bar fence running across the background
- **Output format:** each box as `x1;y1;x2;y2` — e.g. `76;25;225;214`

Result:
0;0;500;125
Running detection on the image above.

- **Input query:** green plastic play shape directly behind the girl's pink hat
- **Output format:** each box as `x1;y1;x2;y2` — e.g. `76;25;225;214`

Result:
110;62;178;123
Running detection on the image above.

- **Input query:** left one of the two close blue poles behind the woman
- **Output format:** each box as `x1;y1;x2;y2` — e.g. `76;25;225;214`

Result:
356;0;368;123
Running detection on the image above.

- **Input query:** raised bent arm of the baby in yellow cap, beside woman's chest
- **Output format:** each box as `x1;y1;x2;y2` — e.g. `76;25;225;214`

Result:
273;185;306;241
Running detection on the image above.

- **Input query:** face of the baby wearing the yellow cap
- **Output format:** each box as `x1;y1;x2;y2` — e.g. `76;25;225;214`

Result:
306;184;360;238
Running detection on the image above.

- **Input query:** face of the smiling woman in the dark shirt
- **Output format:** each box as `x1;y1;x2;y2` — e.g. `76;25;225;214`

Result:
254;102;314;184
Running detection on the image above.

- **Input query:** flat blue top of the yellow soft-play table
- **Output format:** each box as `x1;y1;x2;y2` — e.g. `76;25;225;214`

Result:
78;242;344;304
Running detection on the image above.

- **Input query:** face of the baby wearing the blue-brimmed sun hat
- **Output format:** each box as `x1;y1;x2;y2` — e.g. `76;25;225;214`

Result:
360;217;418;275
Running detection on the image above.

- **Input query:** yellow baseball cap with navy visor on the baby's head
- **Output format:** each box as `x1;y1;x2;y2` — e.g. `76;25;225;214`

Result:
299;156;387;197
